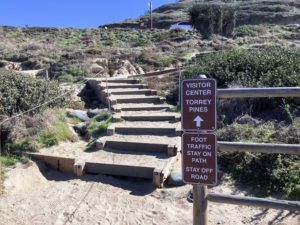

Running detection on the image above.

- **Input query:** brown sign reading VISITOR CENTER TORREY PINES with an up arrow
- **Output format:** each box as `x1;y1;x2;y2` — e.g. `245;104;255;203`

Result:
181;79;217;131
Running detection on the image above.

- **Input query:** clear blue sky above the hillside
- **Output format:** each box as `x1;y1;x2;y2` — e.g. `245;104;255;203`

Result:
0;0;176;28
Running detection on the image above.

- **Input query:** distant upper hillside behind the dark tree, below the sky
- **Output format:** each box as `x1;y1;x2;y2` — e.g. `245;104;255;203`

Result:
103;0;300;29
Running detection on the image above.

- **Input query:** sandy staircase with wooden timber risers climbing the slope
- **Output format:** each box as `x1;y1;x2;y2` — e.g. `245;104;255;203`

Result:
92;78;180;187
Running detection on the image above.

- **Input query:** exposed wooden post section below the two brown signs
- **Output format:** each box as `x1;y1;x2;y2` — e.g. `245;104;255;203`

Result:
193;185;207;225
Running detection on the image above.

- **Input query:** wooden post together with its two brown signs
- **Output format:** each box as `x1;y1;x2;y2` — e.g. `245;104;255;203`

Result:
180;79;217;225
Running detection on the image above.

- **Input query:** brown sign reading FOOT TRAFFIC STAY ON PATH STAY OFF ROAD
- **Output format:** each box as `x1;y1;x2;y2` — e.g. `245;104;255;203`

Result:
182;133;217;185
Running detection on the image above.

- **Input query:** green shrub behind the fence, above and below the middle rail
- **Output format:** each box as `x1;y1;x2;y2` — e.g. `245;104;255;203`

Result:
217;122;300;199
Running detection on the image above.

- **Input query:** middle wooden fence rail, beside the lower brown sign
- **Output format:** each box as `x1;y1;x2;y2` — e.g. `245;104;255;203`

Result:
218;141;300;155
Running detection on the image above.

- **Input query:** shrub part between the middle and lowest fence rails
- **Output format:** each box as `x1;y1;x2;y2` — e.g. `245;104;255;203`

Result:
219;153;300;200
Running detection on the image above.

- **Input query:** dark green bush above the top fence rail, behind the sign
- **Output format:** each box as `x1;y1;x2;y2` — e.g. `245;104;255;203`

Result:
185;47;300;87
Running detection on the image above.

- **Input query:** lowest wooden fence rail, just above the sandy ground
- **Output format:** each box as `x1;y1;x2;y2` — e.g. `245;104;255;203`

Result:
207;194;300;211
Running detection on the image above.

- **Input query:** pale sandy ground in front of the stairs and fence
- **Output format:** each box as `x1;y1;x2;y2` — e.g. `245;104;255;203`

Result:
0;163;300;225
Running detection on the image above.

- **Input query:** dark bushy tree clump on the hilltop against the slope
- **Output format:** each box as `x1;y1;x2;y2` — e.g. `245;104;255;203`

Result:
189;3;237;38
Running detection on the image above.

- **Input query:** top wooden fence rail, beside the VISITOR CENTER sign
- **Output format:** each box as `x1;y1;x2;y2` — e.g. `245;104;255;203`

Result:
217;87;300;98
